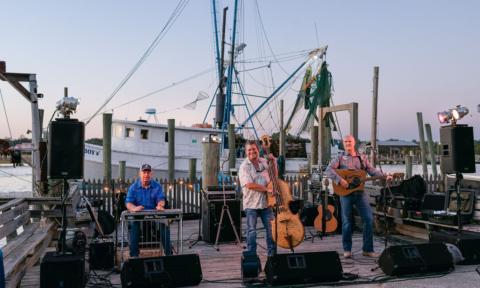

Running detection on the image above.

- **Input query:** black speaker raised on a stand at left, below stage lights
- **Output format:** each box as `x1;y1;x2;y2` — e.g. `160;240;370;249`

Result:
48;119;85;179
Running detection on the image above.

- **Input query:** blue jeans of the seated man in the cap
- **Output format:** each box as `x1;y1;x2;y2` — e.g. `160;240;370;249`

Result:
129;221;172;257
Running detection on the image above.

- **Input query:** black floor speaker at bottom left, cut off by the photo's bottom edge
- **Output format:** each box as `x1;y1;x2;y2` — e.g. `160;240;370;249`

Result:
40;252;85;288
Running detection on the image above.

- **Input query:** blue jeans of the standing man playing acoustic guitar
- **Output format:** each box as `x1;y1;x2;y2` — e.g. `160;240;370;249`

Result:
340;191;373;252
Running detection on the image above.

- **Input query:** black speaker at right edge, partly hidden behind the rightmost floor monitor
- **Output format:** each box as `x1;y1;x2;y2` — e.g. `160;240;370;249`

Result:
429;230;480;265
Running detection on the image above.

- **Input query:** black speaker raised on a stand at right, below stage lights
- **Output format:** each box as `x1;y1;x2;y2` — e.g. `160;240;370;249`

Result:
440;125;475;174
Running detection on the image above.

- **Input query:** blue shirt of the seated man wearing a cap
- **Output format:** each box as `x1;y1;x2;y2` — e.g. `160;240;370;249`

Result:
125;179;165;209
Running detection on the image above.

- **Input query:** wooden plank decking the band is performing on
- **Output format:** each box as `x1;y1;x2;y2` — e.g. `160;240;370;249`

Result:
21;219;478;288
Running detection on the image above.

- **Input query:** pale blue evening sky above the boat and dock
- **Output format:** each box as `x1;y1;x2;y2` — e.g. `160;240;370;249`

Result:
0;0;480;140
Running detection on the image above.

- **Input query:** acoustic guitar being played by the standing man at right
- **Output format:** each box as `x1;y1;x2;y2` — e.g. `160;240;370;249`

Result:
332;169;404;196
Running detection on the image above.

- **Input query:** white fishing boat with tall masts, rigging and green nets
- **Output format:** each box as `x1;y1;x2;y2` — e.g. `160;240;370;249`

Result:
84;1;338;179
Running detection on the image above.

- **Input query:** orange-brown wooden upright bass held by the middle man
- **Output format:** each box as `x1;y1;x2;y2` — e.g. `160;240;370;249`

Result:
260;135;305;250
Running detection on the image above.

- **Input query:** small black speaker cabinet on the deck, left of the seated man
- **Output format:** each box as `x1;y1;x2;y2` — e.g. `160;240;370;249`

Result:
88;239;115;270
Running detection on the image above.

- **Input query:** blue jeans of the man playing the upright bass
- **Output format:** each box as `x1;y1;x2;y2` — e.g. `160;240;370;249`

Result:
245;208;276;256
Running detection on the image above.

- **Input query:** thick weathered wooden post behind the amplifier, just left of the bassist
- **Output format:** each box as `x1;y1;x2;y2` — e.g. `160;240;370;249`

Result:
202;135;221;188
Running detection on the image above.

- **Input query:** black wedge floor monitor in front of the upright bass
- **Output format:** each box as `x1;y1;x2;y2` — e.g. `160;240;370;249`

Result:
265;251;343;285
